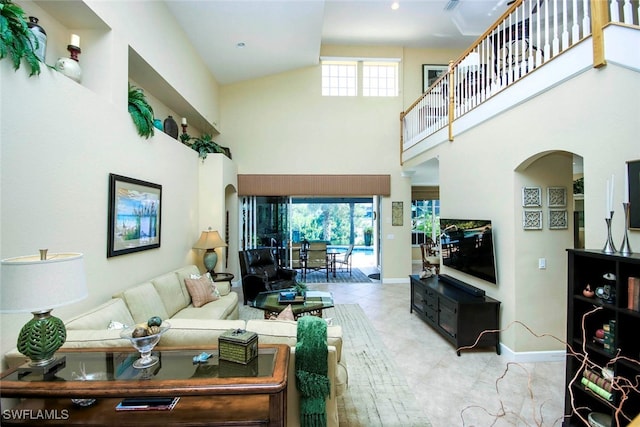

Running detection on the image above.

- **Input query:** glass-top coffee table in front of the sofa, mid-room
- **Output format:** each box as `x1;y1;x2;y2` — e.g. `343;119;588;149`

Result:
252;289;333;319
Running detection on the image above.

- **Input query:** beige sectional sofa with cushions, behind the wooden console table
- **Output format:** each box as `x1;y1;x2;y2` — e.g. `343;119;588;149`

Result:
5;265;348;427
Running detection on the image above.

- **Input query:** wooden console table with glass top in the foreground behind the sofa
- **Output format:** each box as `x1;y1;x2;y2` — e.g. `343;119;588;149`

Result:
0;345;290;427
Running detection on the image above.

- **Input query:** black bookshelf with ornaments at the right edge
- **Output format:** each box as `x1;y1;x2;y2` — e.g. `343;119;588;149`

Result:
564;249;640;427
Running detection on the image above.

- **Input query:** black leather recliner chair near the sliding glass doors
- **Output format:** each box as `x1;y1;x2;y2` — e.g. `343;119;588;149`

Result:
240;248;297;304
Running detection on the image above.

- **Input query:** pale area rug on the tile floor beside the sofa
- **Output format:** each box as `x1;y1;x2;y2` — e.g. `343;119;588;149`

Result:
240;304;431;427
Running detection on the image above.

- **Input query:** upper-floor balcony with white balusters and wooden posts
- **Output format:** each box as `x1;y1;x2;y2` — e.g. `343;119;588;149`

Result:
400;0;640;163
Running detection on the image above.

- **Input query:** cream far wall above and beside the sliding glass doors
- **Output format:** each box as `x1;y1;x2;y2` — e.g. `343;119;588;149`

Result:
218;48;417;282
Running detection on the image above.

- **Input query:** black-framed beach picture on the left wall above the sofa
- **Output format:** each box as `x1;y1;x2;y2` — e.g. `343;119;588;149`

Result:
107;173;162;258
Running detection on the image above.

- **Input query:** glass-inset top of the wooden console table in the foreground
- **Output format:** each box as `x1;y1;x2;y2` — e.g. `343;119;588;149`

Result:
0;345;288;397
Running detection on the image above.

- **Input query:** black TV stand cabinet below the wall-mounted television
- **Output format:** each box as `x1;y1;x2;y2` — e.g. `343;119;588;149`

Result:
409;275;500;356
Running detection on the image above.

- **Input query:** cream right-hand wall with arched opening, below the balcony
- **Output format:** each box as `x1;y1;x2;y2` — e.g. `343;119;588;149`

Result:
407;64;640;352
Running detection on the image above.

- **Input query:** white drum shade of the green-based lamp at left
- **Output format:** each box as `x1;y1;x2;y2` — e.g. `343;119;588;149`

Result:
0;253;88;313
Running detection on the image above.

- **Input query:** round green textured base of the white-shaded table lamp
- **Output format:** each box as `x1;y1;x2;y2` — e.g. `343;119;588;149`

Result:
18;310;67;366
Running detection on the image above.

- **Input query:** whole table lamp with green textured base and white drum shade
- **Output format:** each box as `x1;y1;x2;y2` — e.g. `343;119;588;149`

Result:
0;249;88;375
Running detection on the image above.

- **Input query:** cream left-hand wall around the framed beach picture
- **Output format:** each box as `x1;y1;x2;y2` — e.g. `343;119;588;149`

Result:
0;1;218;363
